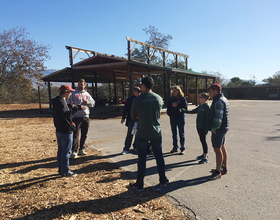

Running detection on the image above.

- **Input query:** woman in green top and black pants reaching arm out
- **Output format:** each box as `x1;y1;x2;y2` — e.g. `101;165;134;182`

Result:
182;92;209;164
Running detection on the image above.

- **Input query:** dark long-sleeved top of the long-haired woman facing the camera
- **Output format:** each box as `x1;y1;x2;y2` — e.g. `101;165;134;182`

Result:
167;96;188;119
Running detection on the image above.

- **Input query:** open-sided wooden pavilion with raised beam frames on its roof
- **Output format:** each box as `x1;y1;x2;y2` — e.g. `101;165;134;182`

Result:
42;37;216;108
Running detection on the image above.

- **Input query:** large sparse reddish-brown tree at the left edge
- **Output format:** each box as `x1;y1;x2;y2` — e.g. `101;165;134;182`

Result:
0;27;50;102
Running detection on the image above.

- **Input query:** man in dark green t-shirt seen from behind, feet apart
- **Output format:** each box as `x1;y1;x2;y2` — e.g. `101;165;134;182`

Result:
130;76;169;192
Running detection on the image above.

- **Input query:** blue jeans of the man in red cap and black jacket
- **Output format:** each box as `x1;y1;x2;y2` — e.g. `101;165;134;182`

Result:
56;132;73;176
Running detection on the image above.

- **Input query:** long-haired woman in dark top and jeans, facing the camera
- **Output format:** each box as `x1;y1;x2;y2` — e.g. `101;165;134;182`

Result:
166;86;188;155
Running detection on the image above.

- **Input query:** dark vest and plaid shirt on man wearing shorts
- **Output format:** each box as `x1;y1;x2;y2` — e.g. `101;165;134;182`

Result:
208;93;229;132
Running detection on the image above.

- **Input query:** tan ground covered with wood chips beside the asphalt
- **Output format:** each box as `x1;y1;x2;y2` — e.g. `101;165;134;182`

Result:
0;104;190;220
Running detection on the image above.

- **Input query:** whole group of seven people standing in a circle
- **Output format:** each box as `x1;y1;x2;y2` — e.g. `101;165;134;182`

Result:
53;76;229;191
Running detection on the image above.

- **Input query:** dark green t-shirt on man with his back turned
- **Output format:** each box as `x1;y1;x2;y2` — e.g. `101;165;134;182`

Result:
131;92;163;140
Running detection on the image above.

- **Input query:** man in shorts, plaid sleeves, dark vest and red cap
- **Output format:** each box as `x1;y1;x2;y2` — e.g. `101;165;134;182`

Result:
208;84;229;180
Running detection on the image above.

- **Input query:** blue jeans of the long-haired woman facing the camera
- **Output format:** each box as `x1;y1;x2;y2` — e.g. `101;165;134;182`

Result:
170;118;185;151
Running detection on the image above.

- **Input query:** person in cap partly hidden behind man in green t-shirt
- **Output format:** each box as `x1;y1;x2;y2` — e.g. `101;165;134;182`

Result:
121;87;141;154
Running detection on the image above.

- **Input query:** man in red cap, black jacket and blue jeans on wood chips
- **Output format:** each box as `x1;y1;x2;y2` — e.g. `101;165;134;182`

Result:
52;85;84;177
